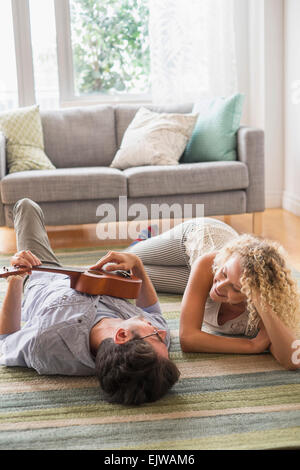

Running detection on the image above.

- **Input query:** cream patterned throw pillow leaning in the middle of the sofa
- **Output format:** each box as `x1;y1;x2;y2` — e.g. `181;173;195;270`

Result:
110;107;197;170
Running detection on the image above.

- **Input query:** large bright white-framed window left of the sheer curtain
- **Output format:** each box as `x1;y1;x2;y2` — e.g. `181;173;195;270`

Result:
0;0;150;110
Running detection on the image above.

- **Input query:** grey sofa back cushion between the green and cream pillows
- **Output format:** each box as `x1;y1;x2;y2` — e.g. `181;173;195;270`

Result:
41;105;117;168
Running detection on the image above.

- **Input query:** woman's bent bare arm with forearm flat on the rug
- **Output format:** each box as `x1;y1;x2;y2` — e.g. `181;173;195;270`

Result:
179;253;269;354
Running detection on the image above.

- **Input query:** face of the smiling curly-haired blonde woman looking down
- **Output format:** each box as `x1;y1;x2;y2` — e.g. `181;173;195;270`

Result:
209;255;246;304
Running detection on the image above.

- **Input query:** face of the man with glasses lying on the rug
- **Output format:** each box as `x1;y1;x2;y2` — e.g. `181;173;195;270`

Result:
122;316;169;358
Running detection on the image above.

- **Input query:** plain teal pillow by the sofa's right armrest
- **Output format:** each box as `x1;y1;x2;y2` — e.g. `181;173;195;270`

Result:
180;93;244;163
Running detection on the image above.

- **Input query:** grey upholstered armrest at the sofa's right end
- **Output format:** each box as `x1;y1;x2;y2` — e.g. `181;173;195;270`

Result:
237;127;265;212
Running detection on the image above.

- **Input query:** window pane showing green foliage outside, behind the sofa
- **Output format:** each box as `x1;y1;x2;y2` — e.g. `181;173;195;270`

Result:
70;0;150;95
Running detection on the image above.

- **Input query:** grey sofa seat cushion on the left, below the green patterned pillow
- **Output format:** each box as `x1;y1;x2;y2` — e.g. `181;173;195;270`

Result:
1;167;127;204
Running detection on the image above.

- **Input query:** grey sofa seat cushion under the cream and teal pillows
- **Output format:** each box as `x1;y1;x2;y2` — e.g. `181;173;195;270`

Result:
124;162;249;197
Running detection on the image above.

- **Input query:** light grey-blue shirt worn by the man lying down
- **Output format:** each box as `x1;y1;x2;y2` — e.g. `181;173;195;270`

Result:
0;273;170;375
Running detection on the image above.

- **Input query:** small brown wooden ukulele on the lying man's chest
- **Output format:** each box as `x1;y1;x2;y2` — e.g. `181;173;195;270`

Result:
0;265;142;299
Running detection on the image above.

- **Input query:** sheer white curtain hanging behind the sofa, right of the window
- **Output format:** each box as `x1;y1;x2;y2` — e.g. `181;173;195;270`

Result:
149;0;237;104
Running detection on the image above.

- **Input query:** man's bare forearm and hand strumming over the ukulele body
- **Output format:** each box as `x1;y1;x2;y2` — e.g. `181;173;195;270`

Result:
90;251;158;308
